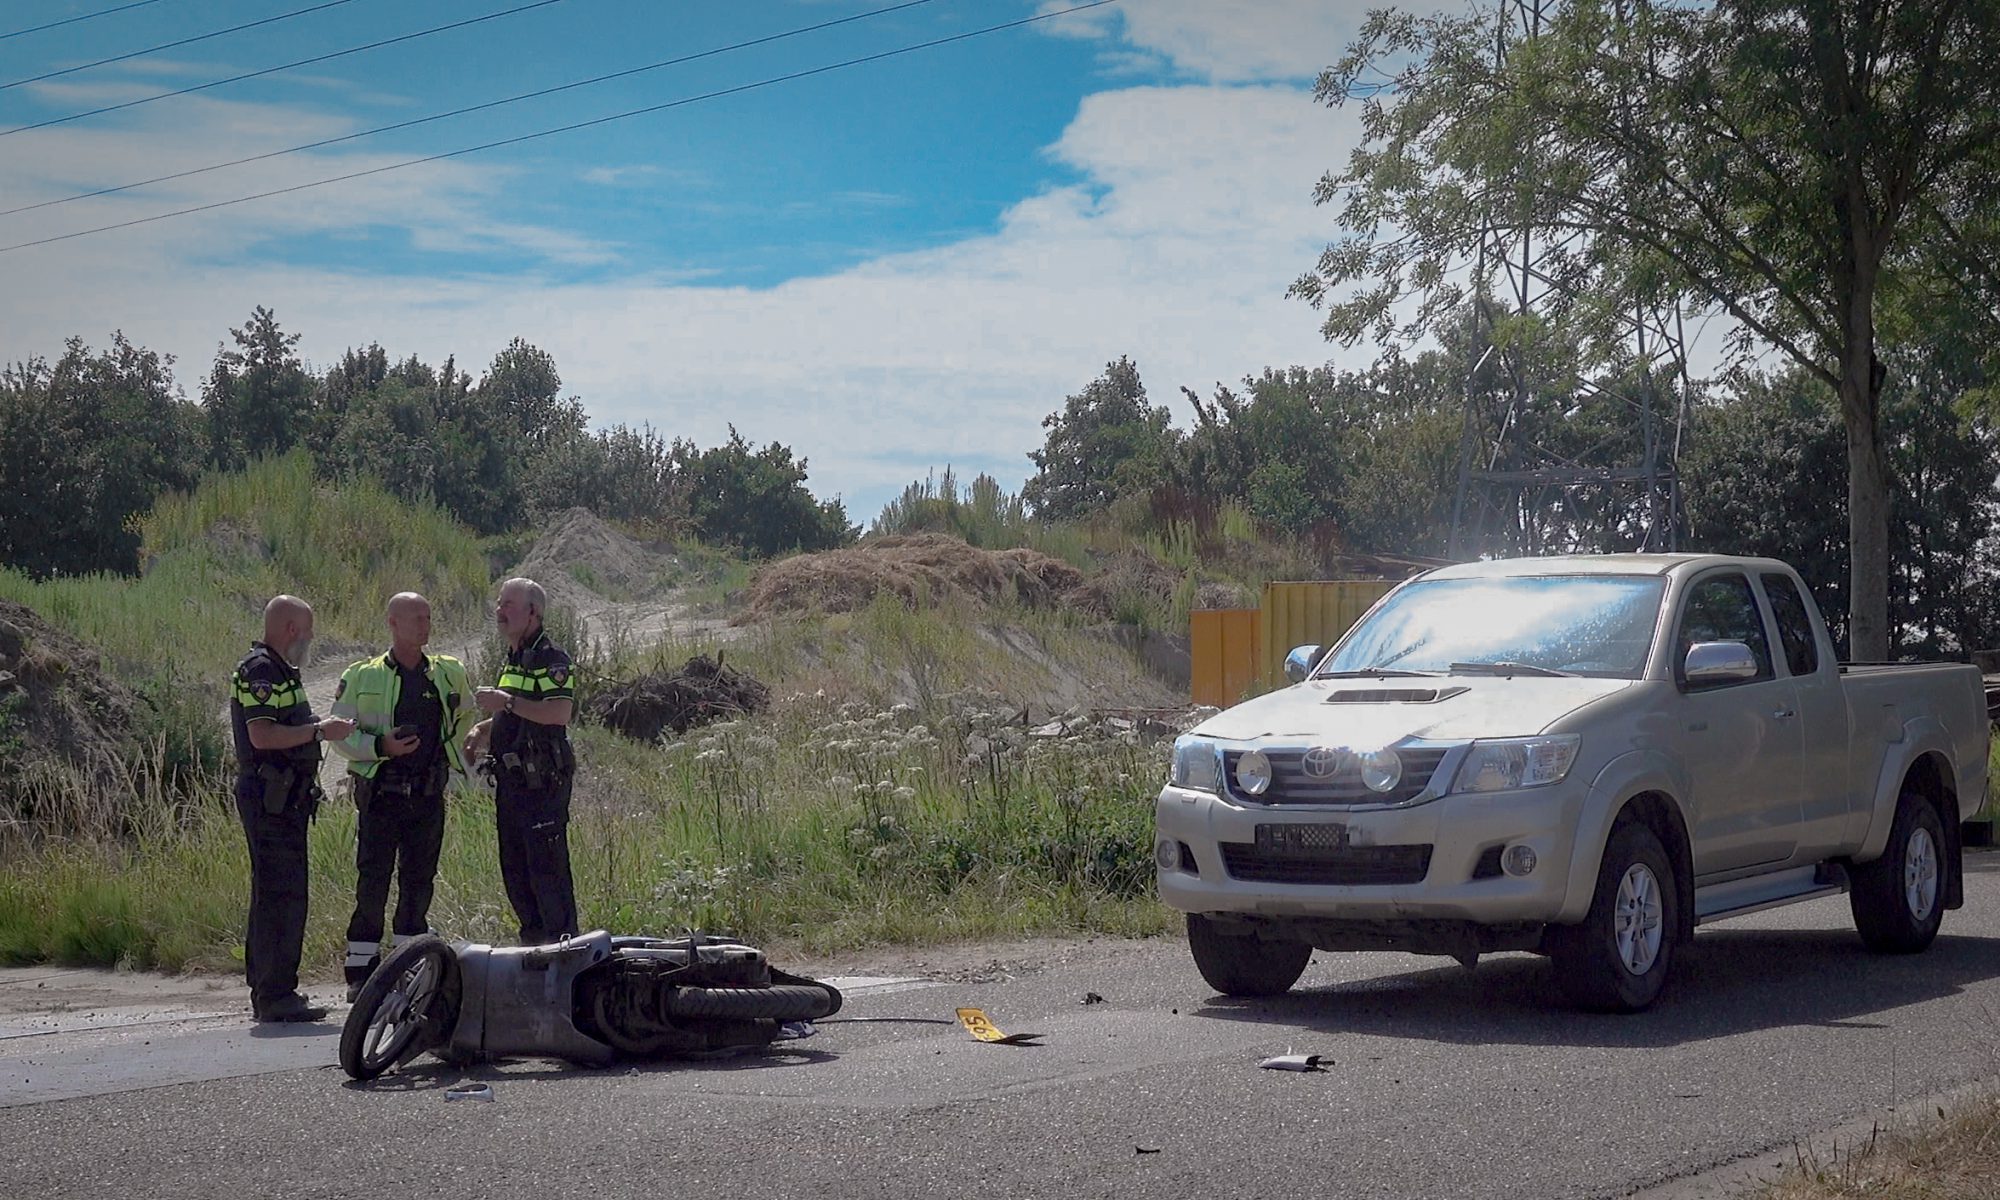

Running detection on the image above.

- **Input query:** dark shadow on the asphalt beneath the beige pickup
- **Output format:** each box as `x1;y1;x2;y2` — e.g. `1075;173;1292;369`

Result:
1196;930;2000;1046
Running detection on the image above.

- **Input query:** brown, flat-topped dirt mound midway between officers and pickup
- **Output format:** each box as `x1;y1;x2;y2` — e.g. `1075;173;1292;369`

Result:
738;534;1084;622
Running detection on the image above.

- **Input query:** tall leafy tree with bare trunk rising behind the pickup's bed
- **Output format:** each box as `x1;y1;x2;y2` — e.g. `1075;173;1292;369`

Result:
1294;0;2000;658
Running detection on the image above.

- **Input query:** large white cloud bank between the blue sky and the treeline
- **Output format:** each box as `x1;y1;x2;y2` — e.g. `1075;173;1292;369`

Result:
0;86;1366;520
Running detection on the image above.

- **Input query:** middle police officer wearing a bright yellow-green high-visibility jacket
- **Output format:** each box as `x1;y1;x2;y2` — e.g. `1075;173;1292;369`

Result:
334;592;474;1000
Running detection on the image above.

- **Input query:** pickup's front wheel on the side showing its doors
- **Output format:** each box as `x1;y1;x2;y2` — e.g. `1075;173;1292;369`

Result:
1548;822;1680;1012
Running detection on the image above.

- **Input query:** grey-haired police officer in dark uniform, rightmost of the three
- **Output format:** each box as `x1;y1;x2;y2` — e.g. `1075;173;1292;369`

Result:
466;578;576;946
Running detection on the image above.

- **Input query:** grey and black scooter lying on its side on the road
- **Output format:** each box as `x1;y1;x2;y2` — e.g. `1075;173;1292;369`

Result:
340;930;840;1080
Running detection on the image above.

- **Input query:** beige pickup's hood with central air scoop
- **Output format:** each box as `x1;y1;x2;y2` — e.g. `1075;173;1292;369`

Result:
1192;676;1634;750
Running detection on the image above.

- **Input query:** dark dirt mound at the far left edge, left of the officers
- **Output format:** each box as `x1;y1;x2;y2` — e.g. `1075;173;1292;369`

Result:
0;600;138;814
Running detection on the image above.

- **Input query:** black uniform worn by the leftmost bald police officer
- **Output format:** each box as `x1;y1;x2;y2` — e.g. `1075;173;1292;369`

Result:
230;642;320;1016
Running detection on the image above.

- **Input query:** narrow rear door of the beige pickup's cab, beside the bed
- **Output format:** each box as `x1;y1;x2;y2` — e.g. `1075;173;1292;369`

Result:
1758;572;1854;860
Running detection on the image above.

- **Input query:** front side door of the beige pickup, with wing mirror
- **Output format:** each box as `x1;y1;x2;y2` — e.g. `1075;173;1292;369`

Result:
1674;570;1804;878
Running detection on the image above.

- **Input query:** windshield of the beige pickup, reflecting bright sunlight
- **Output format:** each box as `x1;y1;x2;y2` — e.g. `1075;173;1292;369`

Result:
1318;576;1666;680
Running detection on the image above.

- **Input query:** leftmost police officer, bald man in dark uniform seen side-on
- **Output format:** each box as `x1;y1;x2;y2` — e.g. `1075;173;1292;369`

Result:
230;596;354;1022
